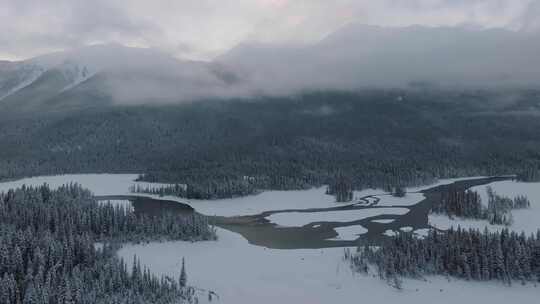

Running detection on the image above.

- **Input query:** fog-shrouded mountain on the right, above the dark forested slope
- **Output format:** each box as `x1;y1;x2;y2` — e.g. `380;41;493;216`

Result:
218;24;540;93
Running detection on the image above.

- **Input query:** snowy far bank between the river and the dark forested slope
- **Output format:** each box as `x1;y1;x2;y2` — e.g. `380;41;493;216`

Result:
0;174;480;216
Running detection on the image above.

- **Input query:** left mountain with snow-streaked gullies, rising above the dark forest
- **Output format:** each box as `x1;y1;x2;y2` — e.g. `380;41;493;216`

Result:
0;45;245;110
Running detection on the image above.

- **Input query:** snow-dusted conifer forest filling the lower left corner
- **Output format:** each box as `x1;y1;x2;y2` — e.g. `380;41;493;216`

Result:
0;184;215;304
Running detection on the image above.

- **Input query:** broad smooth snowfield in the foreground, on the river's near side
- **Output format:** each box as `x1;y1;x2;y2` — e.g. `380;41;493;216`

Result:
118;229;540;304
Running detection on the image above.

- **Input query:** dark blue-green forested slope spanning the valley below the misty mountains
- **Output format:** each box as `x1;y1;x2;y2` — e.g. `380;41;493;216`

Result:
0;89;540;198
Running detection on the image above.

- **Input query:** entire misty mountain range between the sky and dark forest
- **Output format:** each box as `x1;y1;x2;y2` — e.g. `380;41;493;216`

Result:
0;24;540;110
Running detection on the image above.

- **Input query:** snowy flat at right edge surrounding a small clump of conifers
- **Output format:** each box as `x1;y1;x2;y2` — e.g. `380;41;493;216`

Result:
429;181;540;234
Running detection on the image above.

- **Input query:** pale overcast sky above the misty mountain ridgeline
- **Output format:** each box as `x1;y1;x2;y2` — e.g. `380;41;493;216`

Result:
0;0;540;60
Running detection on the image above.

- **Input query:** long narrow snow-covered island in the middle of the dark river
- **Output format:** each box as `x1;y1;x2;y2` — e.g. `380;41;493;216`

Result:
267;208;409;227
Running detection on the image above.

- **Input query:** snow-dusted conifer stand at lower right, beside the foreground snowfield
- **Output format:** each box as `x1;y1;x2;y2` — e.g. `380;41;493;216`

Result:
345;228;540;288
